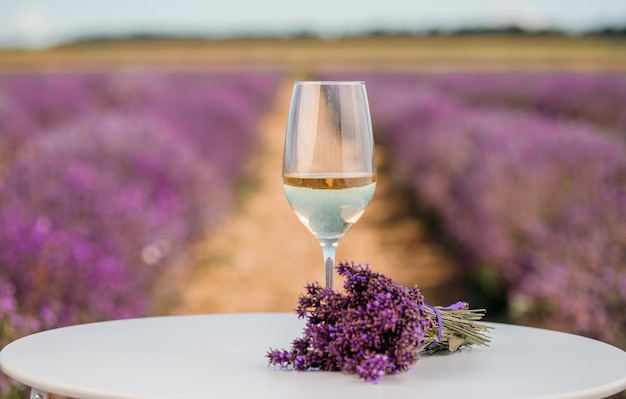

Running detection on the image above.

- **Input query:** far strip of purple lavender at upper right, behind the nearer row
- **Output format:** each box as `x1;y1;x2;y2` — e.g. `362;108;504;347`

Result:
429;73;626;134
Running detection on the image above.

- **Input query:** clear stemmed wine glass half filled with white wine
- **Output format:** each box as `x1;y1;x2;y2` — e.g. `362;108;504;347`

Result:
283;81;376;289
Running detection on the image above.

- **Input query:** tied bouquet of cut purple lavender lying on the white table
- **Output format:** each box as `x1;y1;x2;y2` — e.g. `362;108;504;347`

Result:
266;262;491;383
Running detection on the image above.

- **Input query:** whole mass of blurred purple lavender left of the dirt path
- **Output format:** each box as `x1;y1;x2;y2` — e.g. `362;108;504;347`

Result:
0;72;279;394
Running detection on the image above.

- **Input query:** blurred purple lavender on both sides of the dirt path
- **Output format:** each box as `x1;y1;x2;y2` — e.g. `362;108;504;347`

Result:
0;66;626;394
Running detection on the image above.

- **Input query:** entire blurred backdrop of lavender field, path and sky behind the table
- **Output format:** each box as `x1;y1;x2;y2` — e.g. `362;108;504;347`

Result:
0;0;626;398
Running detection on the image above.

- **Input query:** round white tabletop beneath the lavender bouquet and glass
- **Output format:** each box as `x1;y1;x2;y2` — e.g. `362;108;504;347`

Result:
0;313;626;399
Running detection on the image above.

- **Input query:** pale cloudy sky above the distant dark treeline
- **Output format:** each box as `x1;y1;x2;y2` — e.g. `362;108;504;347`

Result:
0;0;626;49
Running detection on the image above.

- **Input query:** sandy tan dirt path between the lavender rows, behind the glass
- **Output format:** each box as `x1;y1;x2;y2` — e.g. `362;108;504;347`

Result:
171;79;458;314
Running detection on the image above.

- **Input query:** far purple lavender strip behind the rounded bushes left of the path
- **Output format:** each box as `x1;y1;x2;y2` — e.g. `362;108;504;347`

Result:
0;72;277;170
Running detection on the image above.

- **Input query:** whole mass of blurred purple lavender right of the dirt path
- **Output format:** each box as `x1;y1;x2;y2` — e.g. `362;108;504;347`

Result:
324;73;626;347
